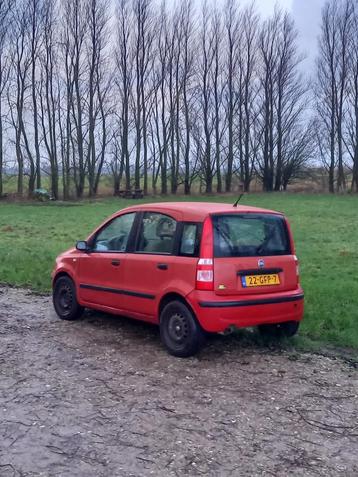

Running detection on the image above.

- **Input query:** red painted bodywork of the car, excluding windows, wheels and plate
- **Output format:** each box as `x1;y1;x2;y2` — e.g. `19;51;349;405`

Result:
52;202;304;332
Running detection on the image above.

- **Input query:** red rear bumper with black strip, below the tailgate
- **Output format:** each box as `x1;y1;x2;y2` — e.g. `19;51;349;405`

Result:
187;288;304;332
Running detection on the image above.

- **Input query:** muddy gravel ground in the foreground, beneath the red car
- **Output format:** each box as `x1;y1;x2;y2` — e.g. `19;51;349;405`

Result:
0;288;358;477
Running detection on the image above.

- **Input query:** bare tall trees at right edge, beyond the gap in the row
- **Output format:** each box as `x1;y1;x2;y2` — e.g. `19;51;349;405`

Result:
314;0;358;192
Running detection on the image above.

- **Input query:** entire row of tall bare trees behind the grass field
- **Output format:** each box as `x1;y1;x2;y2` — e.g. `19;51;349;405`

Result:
0;0;358;199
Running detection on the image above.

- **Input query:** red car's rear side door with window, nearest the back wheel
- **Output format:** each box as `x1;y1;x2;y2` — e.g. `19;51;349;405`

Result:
119;212;178;317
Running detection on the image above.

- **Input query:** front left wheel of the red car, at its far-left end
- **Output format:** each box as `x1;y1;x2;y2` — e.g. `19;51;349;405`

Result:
52;277;84;321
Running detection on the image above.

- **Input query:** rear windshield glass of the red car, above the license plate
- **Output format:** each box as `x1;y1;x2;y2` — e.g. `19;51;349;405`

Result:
213;214;291;257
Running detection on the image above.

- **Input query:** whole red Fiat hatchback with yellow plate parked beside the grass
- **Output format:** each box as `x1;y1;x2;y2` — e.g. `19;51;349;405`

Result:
53;202;304;357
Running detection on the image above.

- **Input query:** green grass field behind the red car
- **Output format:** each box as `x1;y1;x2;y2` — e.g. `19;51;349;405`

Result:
0;194;358;348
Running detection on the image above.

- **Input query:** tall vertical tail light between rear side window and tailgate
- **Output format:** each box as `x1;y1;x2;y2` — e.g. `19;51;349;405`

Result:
196;217;214;290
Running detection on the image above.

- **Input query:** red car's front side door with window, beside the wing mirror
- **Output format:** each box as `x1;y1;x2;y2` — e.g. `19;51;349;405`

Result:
79;212;136;310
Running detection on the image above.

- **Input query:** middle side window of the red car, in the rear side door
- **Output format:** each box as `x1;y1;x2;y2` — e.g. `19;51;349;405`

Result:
136;212;177;253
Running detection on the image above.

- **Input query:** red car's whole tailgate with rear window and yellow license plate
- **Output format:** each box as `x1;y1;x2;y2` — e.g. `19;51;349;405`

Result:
212;213;297;295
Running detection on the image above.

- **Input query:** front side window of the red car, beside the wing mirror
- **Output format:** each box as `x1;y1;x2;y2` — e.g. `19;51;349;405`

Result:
92;213;135;252
